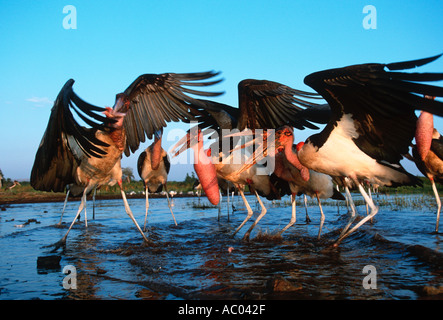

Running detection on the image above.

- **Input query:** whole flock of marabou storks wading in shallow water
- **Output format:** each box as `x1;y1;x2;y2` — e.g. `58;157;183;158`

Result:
31;55;443;247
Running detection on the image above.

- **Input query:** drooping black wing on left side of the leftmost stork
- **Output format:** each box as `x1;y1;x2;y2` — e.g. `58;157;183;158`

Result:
31;79;113;192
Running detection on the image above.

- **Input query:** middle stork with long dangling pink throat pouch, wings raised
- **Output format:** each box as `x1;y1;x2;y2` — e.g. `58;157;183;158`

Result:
172;79;319;240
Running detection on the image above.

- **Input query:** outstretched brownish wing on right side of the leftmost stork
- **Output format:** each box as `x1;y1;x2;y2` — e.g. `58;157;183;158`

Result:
123;71;222;156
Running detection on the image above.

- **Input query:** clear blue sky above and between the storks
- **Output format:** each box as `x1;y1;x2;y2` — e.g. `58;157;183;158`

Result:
0;0;443;180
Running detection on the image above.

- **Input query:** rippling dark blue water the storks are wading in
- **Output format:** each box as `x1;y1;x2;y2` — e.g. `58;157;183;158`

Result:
0;192;443;300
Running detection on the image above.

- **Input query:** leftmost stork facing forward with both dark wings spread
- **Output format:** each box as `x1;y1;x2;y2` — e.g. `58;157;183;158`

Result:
31;72;221;248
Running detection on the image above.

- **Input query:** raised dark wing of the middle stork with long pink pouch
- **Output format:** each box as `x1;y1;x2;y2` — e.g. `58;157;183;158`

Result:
237;79;321;130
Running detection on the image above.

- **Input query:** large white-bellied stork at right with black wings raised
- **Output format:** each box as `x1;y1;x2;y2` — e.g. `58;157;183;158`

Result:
238;55;443;245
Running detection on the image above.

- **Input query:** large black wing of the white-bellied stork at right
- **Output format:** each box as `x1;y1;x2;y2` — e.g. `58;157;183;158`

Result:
304;55;443;163
